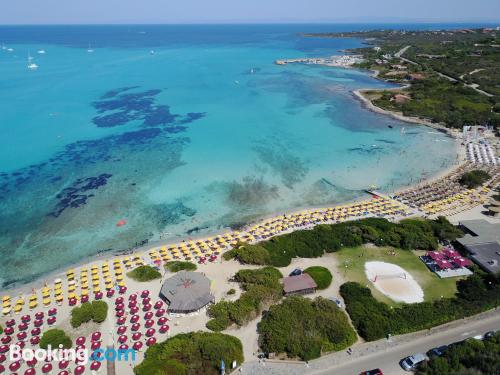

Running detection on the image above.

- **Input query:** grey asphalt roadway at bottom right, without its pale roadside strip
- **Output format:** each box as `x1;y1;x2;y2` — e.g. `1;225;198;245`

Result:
310;311;500;375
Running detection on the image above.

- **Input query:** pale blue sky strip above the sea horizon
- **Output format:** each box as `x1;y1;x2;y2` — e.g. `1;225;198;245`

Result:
0;0;500;24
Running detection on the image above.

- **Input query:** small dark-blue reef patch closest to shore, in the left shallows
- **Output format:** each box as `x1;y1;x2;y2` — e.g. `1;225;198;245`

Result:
49;173;112;217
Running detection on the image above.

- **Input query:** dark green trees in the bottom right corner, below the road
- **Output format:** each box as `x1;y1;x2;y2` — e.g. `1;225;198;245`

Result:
416;333;500;375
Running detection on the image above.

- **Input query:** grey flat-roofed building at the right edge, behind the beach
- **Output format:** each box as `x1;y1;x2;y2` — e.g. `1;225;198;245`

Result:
457;220;500;273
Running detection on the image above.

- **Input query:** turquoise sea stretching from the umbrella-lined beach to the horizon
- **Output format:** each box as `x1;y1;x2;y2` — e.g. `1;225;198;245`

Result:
0;25;464;288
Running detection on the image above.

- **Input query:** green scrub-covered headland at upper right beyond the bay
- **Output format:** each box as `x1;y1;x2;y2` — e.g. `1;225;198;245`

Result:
306;29;500;129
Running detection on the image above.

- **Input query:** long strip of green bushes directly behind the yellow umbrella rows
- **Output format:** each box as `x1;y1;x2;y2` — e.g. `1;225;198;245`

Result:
224;218;462;267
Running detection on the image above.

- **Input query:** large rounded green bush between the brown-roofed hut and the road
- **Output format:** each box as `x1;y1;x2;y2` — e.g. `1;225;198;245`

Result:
258;296;356;361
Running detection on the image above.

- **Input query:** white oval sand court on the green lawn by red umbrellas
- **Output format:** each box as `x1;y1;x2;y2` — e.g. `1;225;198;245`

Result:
365;262;424;303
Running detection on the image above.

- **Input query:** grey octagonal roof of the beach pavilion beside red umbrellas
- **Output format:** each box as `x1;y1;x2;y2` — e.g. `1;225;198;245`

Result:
160;271;214;314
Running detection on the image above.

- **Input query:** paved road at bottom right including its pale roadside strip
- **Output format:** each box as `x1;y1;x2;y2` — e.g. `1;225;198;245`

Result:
242;310;500;375
